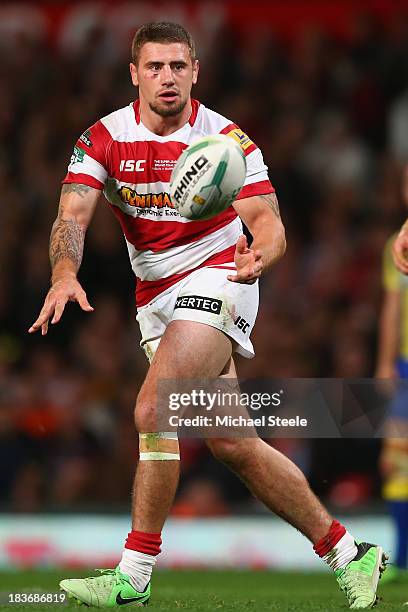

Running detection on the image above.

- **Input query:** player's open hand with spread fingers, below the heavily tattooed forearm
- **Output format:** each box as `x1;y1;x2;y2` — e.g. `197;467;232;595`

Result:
28;276;93;336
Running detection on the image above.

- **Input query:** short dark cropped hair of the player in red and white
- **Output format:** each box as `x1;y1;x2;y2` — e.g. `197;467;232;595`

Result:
132;21;195;65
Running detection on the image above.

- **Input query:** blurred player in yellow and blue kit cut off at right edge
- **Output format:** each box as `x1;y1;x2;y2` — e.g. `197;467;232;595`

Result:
376;167;408;582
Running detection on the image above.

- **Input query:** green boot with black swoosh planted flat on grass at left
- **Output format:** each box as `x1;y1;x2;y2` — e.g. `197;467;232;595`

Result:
60;567;150;608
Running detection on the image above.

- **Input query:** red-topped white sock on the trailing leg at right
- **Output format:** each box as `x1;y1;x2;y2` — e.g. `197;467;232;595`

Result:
313;521;357;570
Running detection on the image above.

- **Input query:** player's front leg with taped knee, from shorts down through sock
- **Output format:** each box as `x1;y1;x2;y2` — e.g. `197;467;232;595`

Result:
119;321;236;591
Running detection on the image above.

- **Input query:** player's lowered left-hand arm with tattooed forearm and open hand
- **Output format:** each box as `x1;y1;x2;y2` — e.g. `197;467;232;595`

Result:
28;183;100;336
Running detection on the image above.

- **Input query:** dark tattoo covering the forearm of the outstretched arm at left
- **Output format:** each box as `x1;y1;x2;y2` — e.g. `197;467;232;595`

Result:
50;215;85;269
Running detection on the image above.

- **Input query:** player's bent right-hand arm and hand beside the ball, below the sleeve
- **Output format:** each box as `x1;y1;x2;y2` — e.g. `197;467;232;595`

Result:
228;193;286;284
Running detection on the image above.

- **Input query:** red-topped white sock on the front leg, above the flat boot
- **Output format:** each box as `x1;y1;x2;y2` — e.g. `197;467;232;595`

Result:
119;531;161;593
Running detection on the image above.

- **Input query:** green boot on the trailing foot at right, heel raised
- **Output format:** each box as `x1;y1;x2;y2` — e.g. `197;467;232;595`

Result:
335;542;387;610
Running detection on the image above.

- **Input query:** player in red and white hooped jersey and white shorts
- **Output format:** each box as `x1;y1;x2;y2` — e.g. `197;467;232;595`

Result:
29;22;384;608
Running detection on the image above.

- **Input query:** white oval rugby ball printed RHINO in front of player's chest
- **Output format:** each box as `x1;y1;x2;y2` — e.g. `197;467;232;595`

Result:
170;134;246;221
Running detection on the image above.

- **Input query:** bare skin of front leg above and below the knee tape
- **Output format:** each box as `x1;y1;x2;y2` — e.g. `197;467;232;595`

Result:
132;321;232;533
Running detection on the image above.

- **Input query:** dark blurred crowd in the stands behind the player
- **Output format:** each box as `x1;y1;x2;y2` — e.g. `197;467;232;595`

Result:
0;8;408;516
